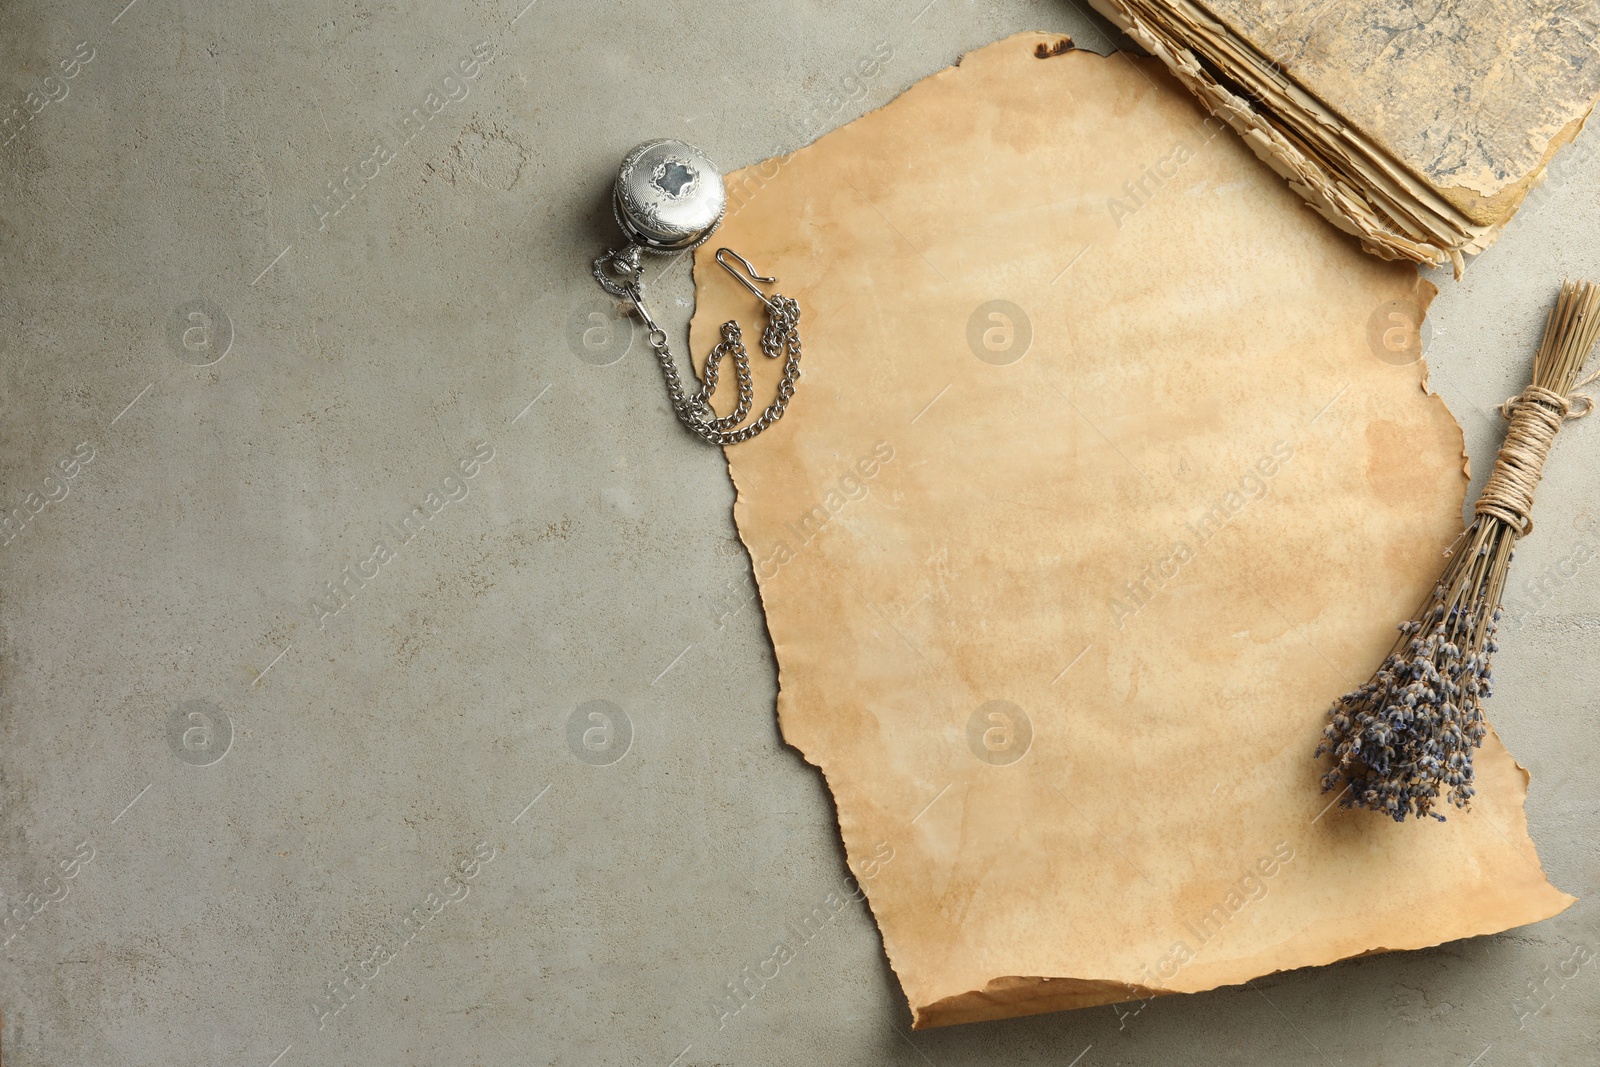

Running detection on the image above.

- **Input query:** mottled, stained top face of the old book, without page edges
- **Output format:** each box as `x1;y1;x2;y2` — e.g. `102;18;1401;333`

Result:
1202;0;1600;221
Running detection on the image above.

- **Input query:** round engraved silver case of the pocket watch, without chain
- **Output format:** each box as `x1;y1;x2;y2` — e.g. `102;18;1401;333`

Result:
613;139;728;251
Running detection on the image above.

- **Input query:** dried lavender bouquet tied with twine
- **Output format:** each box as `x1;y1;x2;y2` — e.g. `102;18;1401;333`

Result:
1317;282;1600;822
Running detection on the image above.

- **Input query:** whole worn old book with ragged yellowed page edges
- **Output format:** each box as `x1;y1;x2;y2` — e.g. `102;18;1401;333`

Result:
1091;0;1600;277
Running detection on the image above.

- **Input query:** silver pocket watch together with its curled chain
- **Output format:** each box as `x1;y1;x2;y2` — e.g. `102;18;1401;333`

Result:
594;141;800;445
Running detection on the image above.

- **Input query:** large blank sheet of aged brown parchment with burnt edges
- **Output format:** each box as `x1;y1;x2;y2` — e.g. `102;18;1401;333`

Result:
693;35;1573;1027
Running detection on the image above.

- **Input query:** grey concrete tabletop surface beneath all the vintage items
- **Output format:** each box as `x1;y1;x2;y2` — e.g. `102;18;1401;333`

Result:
0;0;1600;1067
